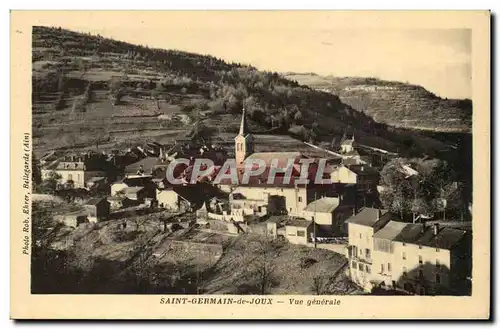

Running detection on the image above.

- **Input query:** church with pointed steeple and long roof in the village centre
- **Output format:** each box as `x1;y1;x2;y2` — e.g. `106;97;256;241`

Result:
219;109;348;229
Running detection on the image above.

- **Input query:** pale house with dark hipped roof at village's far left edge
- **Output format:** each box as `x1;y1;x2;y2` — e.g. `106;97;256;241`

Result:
41;152;113;188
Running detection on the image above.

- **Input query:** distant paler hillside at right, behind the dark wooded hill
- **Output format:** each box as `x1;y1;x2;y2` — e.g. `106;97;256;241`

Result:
284;73;472;132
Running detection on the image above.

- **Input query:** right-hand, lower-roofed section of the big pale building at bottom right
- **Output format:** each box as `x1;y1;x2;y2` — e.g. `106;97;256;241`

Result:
391;220;472;295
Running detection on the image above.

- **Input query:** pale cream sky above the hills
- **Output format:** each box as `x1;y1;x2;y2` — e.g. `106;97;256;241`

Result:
37;11;472;98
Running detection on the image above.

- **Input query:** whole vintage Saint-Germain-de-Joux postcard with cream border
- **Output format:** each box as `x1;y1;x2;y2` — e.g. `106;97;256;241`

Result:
10;11;491;320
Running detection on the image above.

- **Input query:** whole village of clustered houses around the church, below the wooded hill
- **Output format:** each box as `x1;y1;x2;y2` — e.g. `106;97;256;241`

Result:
34;110;472;295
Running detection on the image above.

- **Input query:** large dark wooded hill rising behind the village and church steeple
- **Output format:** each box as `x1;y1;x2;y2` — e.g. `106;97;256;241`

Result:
32;27;454;156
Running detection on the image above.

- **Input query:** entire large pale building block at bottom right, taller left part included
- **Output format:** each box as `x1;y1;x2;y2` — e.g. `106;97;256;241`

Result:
347;208;472;295
